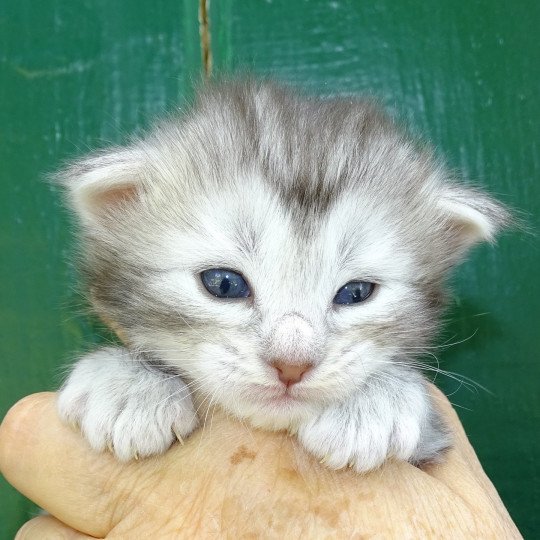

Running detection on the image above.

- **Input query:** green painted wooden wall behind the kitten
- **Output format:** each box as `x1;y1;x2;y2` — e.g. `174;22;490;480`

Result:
0;0;540;539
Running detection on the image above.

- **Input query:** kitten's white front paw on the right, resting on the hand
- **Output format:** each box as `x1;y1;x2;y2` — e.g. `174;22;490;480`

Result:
298;376;431;472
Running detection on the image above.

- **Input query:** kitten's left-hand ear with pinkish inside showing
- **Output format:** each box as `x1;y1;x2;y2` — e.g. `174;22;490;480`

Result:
53;148;143;226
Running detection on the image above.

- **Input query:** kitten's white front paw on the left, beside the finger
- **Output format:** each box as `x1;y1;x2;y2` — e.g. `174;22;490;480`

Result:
57;348;197;461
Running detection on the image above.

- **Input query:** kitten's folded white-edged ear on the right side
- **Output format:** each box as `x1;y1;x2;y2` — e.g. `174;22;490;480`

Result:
438;185;511;254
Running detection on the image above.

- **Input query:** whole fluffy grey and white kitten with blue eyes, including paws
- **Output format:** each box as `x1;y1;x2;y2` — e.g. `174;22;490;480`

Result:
58;81;508;471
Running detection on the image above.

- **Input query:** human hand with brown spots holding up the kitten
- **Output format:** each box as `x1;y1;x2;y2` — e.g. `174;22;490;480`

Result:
0;389;521;540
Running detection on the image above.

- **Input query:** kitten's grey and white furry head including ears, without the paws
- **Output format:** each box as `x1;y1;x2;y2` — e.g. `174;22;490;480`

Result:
57;83;508;429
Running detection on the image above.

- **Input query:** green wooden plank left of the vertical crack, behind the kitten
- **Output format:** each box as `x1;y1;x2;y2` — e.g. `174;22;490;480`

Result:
0;0;201;538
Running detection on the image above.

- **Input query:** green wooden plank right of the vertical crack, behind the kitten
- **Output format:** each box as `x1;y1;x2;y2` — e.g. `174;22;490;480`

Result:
210;0;540;538
